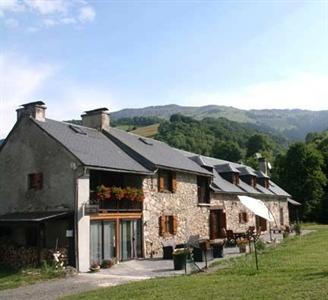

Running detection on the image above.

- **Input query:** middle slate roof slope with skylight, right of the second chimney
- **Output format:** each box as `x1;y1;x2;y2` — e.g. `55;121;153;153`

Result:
108;128;212;176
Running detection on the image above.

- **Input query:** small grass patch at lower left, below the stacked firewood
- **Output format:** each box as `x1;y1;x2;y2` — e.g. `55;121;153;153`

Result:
0;268;64;290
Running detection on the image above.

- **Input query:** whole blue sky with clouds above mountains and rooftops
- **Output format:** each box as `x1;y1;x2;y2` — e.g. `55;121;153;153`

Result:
0;0;328;137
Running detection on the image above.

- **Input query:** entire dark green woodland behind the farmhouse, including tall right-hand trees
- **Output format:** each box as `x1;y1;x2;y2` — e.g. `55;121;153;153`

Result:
116;114;328;223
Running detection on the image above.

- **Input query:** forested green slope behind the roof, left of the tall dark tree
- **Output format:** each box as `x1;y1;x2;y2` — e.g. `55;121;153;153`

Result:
155;114;286;167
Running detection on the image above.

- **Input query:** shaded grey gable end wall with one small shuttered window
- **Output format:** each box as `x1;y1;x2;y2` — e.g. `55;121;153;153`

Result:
0;117;78;214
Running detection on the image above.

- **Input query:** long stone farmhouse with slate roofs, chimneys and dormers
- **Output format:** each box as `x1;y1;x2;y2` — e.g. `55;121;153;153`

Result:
0;101;296;272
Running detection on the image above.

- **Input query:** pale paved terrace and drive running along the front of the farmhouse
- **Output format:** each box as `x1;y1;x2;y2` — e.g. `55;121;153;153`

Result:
0;230;309;300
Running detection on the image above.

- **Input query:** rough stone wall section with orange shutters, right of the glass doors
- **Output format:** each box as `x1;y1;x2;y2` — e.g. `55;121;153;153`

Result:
143;173;209;257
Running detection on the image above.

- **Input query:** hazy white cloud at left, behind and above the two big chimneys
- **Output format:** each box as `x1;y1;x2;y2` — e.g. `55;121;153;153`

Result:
0;54;121;139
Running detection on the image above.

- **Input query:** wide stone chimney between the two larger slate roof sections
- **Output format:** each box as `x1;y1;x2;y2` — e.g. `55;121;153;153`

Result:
81;107;110;131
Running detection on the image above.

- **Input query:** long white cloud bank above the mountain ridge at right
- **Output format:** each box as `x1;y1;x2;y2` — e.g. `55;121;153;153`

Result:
188;73;328;110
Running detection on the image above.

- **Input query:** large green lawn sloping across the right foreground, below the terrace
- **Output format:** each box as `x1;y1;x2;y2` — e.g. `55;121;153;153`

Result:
65;225;328;300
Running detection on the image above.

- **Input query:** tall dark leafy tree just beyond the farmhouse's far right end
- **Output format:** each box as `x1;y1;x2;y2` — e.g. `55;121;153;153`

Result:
276;143;327;221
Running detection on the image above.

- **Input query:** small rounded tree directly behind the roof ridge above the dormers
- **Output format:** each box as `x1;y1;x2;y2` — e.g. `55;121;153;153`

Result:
212;140;242;162
